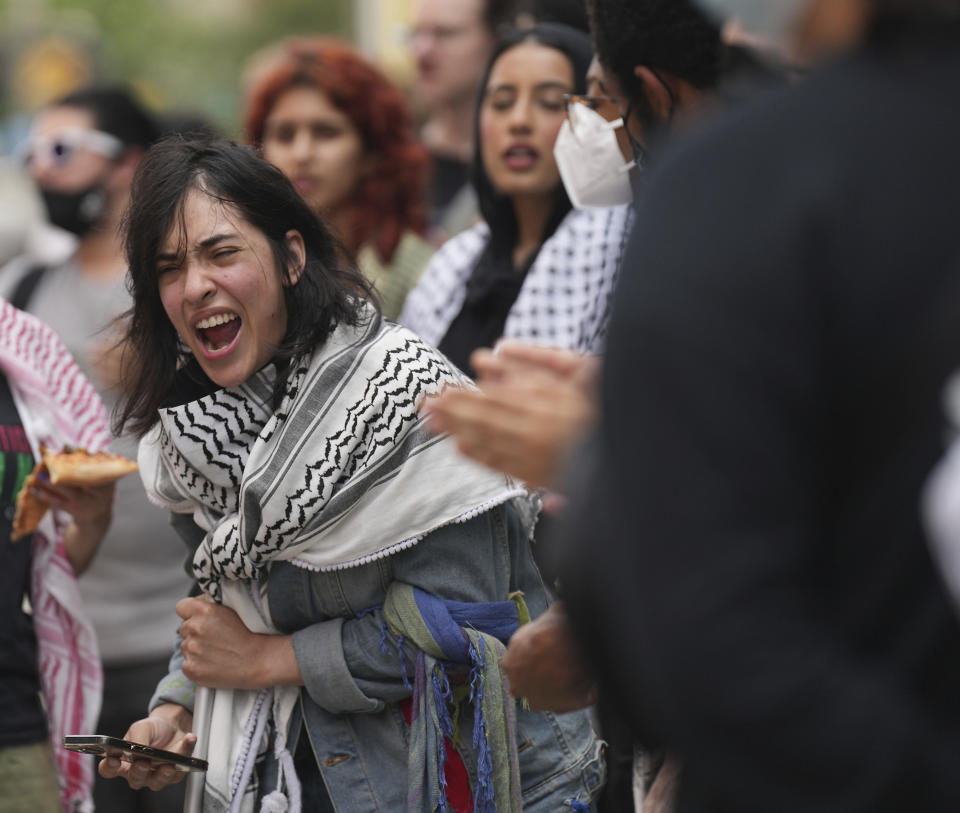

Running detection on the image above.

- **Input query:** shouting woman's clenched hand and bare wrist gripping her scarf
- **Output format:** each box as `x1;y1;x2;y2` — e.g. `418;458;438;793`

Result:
177;598;303;689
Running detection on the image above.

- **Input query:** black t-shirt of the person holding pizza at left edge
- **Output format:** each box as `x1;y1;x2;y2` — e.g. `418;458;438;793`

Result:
0;374;47;747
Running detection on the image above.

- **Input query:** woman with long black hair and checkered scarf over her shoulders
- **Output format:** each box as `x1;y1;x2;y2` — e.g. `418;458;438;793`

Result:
400;23;633;375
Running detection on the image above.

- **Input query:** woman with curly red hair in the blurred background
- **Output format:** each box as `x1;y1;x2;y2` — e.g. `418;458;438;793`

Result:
244;37;433;319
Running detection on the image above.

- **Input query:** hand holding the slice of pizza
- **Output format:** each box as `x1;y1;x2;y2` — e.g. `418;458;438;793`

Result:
33;481;114;576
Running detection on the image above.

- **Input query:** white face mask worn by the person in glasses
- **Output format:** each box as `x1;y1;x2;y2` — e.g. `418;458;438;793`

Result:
553;104;636;209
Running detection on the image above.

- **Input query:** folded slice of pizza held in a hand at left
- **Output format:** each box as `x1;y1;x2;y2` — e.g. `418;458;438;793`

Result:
10;446;137;542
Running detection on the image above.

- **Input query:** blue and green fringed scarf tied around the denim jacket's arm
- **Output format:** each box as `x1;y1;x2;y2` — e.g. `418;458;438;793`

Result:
383;582;528;813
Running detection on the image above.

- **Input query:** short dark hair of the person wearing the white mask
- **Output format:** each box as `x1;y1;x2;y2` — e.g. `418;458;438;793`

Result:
588;0;724;104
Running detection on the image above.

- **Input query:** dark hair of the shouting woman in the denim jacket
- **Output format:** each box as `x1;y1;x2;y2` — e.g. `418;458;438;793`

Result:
115;136;376;435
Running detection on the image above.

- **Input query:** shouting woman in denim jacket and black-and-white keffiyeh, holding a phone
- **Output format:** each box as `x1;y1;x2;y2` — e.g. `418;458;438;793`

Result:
100;139;604;813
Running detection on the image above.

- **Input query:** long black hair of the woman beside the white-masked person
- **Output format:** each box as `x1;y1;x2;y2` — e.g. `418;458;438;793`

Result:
470;23;593;255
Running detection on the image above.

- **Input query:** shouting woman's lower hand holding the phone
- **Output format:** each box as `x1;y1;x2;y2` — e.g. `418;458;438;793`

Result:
97;703;197;790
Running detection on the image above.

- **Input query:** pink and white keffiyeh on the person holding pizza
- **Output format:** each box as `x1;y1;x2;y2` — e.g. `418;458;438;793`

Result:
0;299;110;813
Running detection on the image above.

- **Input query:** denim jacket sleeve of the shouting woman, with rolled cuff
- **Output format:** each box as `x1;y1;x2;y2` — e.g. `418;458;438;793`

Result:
293;506;528;713
